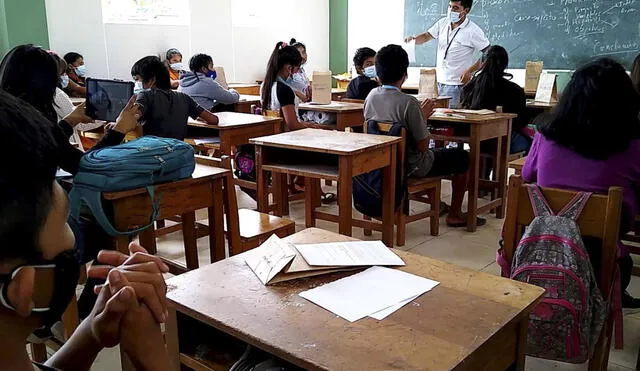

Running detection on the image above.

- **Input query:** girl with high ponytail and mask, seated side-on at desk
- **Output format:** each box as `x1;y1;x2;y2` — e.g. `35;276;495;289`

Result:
262;42;323;131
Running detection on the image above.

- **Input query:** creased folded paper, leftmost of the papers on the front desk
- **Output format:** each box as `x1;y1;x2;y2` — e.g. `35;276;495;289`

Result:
244;235;296;285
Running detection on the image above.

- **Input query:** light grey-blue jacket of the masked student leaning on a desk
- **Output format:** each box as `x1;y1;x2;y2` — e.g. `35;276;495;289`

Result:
178;72;240;109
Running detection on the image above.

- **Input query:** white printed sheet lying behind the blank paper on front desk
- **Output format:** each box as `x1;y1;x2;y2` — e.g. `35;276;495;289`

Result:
296;241;405;267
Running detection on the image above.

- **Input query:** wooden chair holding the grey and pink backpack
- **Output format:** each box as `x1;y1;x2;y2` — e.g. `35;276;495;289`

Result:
503;175;622;371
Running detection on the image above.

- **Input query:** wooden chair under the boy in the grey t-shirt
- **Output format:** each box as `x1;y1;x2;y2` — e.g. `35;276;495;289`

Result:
364;123;442;246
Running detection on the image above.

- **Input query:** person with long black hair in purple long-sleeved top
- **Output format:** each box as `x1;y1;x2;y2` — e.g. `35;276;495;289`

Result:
522;58;640;308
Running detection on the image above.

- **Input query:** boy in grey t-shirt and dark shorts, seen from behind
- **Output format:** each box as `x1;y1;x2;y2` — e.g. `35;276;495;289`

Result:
364;45;486;227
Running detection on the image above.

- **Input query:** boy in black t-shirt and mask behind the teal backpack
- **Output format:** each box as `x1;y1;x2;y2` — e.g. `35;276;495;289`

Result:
131;56;218;140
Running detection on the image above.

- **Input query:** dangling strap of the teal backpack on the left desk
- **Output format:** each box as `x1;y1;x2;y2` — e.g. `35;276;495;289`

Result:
69;186;160;236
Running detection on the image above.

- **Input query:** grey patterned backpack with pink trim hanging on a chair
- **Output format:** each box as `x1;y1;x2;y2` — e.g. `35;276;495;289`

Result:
498;185;607;363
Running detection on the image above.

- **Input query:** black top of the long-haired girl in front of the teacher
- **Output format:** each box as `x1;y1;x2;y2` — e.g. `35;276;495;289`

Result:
462;78;527;131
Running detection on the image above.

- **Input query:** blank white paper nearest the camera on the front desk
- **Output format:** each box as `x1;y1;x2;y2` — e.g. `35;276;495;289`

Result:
299;267;438;322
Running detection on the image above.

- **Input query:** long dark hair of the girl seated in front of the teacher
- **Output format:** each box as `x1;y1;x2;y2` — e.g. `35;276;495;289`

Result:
462;45;513;109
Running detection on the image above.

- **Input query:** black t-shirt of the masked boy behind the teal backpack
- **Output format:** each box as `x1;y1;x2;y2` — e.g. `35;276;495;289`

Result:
136;89;204;140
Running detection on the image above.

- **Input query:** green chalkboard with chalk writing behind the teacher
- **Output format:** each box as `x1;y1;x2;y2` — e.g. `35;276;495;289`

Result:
404;0;640;69
